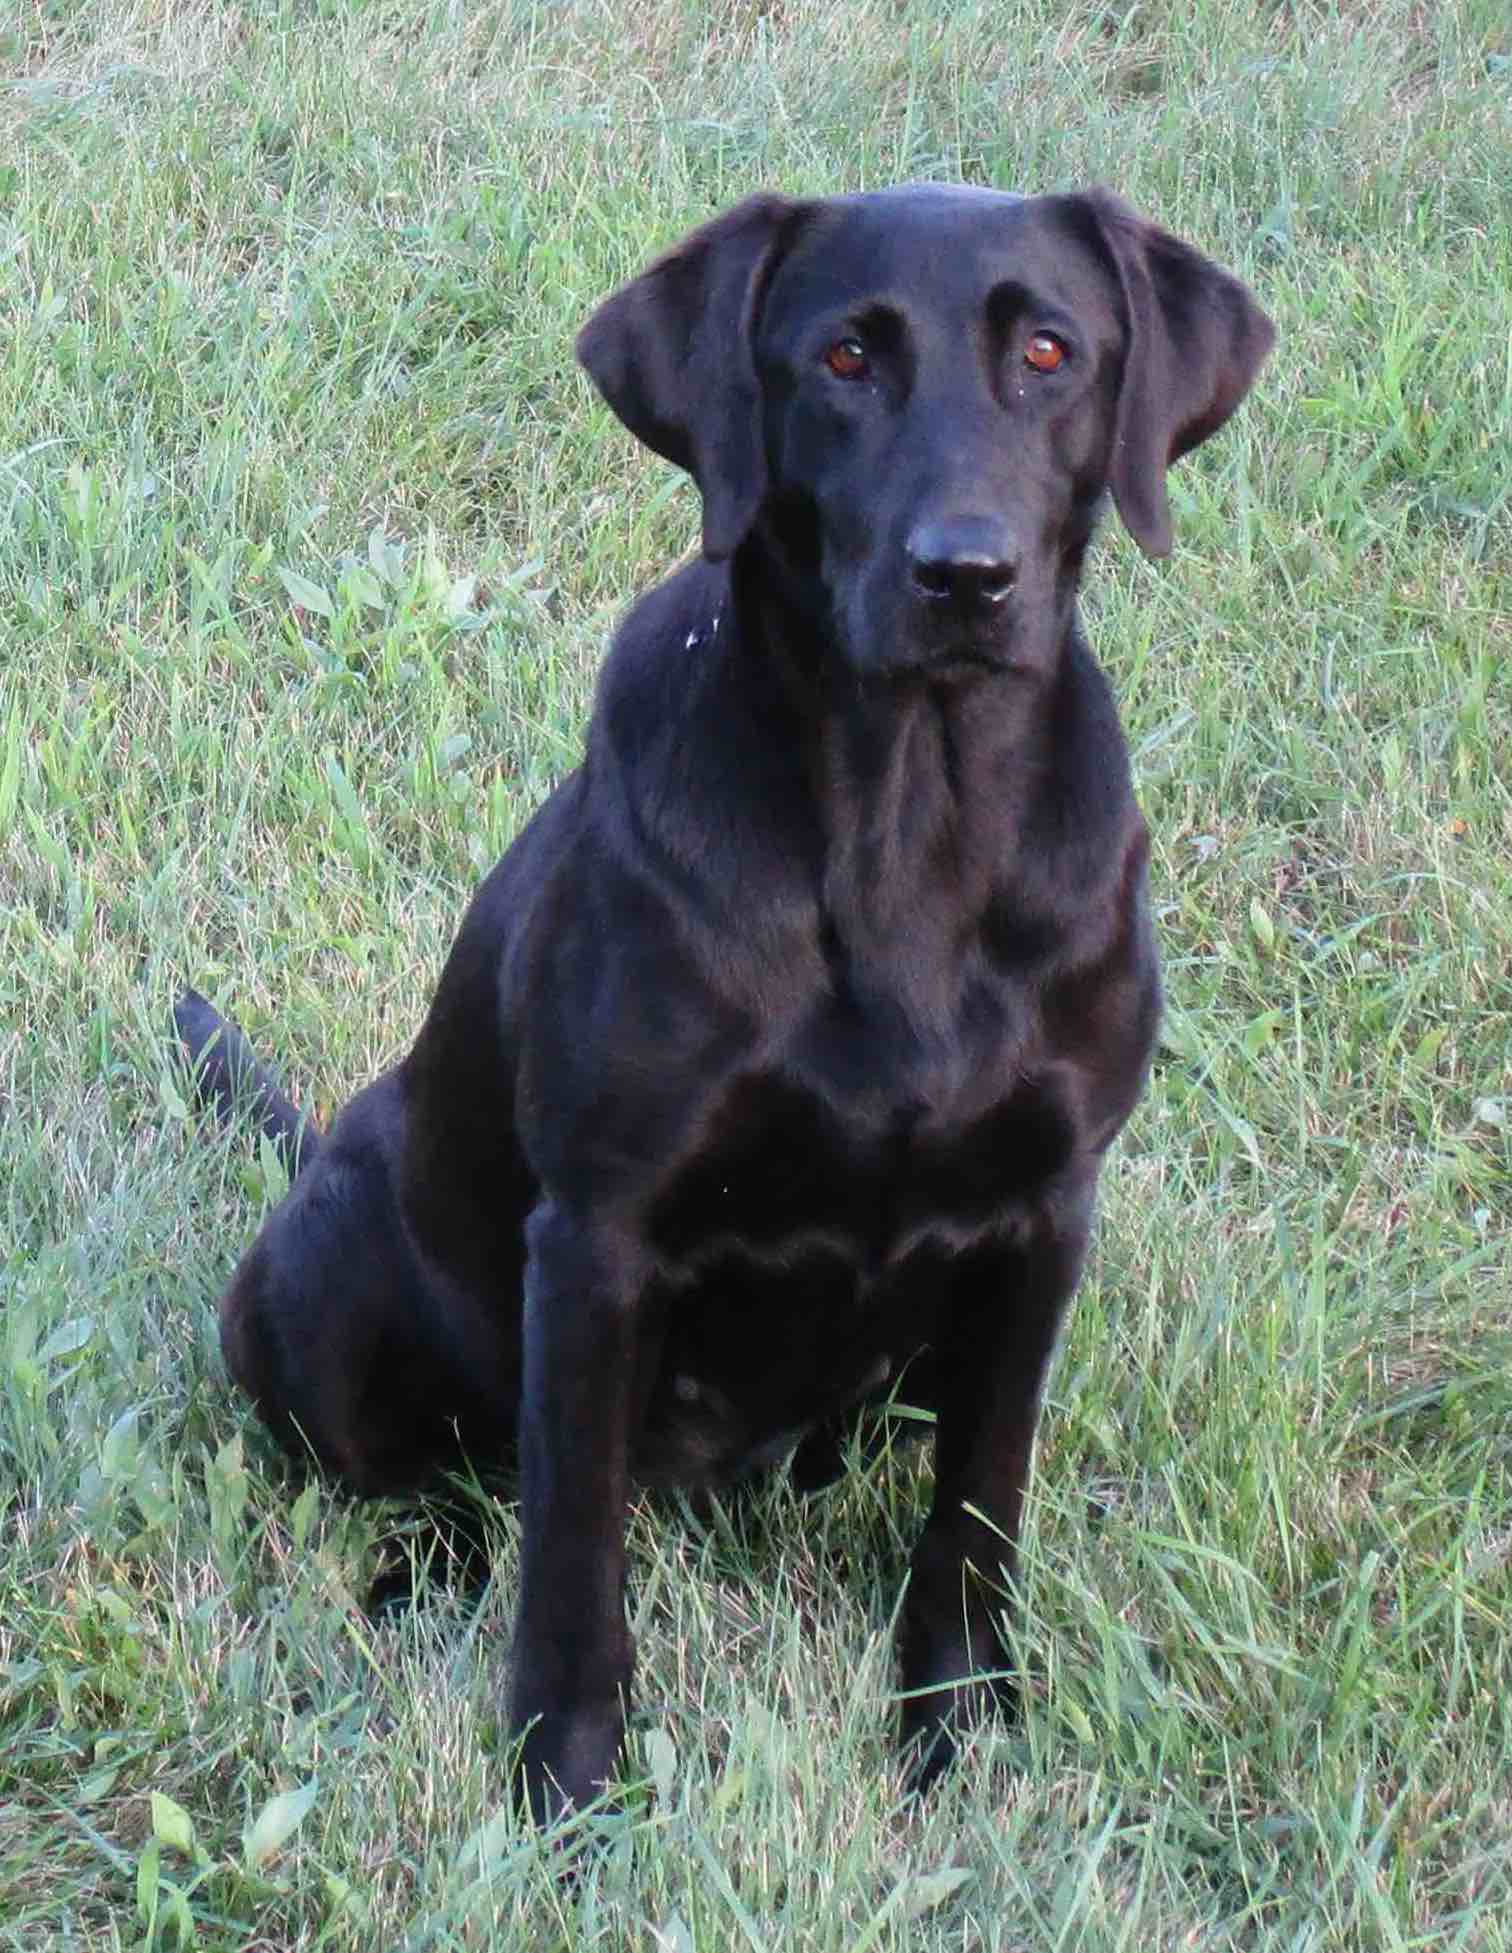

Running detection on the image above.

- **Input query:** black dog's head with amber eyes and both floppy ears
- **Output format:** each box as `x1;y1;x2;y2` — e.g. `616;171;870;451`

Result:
578;186;1272;672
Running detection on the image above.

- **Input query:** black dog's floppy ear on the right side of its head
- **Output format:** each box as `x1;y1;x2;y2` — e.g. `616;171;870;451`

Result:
1084;189;1276;557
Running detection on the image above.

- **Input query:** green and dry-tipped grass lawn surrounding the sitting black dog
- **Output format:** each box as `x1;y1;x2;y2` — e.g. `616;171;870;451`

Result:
0;0;1512;1953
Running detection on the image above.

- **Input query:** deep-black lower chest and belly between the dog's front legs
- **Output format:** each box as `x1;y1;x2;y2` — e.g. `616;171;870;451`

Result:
637;1066;1076;1484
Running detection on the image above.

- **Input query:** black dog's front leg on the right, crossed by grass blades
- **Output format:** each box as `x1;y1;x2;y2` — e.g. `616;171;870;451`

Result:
899;1184;1092;1791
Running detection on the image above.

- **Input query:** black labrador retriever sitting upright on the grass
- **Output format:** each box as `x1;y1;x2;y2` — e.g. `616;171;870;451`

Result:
180;186;1272;1816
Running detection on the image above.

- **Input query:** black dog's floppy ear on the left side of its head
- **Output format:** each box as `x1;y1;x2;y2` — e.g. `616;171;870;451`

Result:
578;195;809;562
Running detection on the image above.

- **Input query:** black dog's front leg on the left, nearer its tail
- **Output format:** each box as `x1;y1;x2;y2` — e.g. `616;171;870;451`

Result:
510;1199;643;1822
